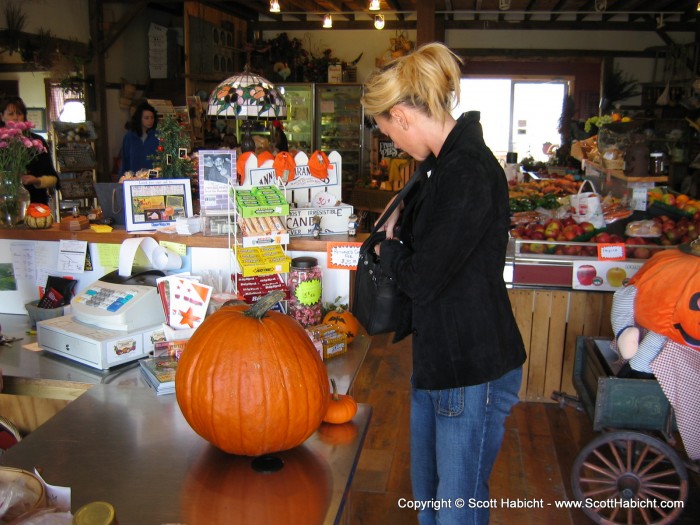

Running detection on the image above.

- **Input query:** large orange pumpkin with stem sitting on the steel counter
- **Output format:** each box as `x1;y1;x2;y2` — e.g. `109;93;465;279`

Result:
175;292;330;456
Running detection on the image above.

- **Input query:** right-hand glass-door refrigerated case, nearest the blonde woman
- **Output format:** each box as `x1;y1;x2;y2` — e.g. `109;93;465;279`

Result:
316;84;364;202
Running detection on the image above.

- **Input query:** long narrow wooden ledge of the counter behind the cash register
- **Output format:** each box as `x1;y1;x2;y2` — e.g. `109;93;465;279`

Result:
0;224;368;252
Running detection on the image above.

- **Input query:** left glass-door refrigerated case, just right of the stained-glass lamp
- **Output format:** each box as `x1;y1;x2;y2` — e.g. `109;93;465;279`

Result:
279;84;316;154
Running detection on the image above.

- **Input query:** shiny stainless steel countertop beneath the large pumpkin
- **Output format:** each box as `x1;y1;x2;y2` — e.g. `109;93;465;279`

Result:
0;378;371;525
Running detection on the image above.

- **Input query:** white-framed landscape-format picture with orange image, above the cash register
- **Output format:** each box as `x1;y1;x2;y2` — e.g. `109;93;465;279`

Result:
124;179;193;232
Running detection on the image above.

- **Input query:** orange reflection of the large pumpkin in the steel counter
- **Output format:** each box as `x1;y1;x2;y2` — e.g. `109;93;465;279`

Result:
180;445;333;525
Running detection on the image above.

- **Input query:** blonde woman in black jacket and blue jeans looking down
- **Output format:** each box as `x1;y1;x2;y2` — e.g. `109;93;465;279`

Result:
362;43;525;525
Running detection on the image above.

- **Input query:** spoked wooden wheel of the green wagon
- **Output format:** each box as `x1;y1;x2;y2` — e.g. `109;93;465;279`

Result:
571;432;688;525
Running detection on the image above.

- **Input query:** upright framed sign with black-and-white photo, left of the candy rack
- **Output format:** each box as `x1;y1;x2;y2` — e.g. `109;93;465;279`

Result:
199;149;238;210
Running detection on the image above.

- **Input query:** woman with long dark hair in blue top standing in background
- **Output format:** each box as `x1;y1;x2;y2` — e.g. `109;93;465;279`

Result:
119;102;159;177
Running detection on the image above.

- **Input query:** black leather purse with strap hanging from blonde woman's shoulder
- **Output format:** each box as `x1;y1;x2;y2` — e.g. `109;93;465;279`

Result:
350;168;421;335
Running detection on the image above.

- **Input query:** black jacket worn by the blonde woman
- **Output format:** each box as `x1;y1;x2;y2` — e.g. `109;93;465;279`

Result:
381;112;526;390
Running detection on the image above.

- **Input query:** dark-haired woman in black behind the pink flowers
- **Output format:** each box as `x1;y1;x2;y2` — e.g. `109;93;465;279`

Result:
0;97;58;204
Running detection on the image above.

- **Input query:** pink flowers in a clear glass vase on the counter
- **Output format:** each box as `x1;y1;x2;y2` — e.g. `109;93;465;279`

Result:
0;121;46;227
